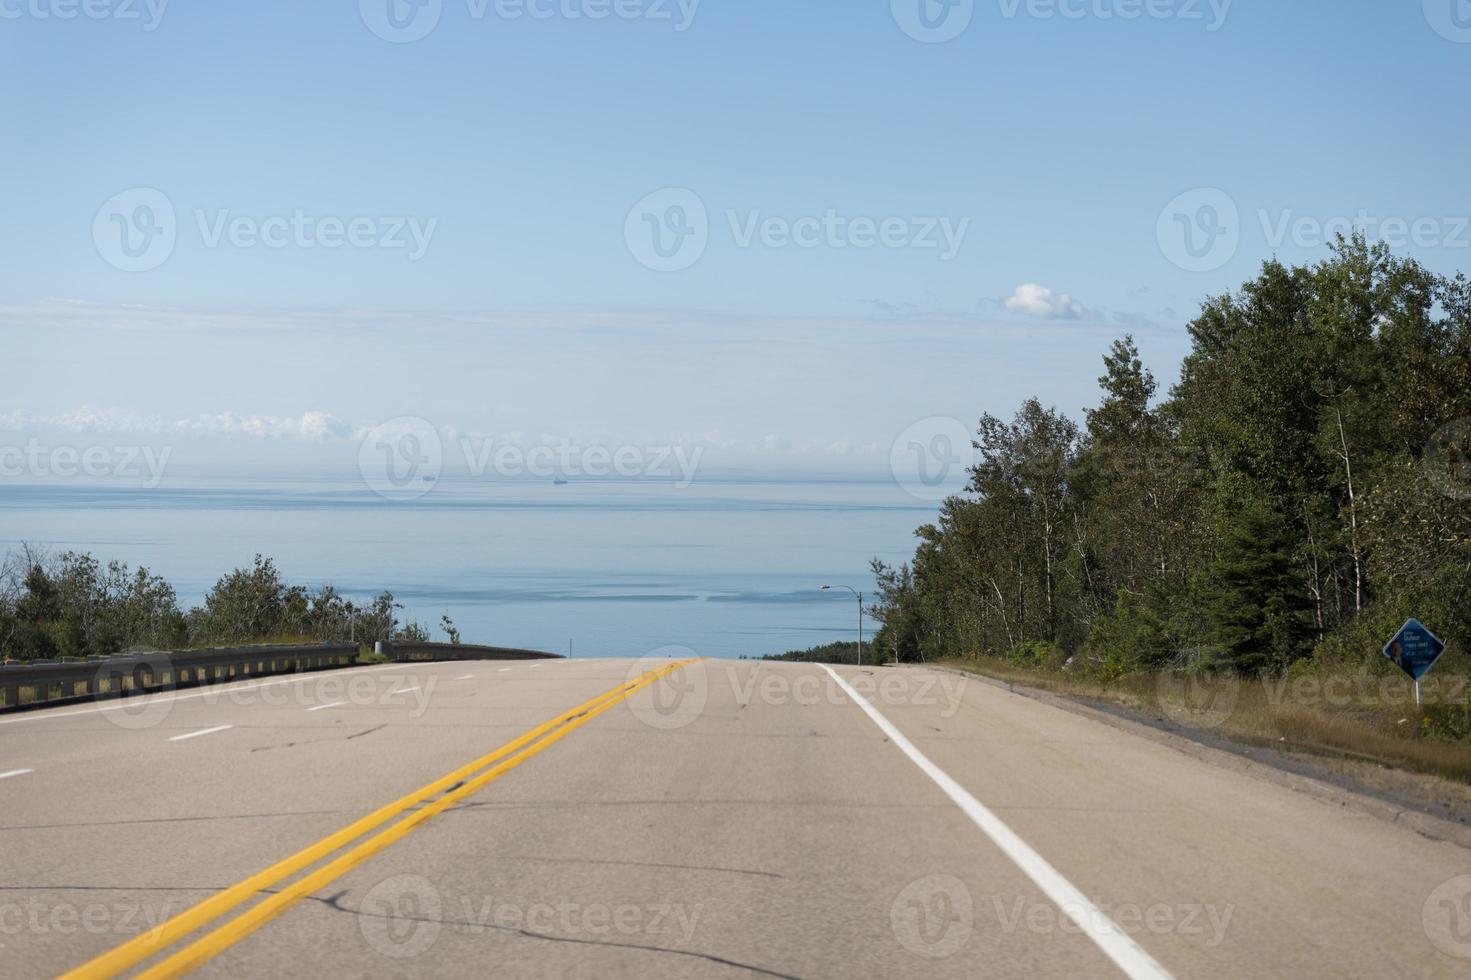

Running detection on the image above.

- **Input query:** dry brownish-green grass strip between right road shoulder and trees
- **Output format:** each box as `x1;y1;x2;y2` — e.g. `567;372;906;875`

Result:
944;658;1471;784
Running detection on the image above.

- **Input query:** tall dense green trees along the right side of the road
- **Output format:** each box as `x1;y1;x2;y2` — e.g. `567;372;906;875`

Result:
872;235;1471;677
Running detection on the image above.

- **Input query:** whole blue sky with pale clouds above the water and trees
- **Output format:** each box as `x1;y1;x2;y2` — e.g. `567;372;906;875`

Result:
0;0;1471;469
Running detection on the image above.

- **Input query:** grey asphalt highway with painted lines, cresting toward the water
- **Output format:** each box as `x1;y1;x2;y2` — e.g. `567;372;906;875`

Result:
0;661;1471;980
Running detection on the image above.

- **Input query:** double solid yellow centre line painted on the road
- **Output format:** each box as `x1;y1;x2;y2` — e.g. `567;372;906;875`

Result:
62;661;694;980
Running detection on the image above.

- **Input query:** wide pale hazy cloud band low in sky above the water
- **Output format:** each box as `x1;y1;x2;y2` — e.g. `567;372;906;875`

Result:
0;294;1111;474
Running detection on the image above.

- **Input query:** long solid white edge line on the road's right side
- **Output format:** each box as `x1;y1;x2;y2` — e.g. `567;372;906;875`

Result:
822;664;1172;980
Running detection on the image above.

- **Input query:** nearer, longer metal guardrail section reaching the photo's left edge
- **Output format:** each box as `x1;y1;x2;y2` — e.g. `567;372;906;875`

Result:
0;643;357;709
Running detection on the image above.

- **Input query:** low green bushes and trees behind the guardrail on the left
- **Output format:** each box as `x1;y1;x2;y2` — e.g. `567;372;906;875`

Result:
0;546;441;662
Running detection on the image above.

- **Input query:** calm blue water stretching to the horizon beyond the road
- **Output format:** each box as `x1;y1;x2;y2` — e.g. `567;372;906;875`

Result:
0;472;934;656
